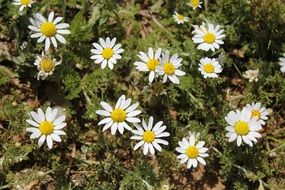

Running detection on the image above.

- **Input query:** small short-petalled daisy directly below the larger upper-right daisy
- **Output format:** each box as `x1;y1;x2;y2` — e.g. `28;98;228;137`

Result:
198;57;223;78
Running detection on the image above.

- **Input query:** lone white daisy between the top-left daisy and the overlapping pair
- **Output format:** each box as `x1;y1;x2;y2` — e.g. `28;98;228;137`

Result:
91;37;124;70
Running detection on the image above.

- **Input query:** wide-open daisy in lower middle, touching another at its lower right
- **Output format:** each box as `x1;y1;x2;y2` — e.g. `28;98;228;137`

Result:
96;95;141;135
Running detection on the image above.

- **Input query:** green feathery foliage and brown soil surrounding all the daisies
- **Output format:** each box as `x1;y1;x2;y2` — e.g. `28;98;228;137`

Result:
0;0;285;190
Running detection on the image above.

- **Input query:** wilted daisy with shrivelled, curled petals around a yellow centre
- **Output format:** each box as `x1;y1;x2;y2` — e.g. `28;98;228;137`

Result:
34;52;61;80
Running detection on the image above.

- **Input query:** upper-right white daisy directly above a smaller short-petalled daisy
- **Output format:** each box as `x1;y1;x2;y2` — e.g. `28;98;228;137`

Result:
192;23;225;51
